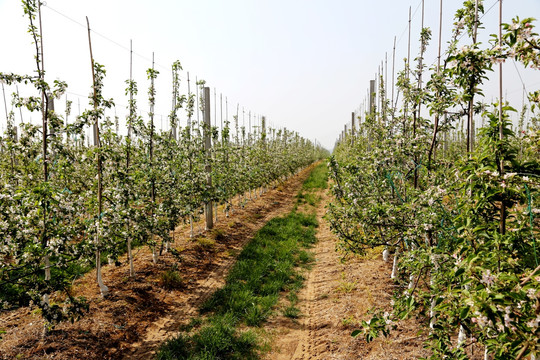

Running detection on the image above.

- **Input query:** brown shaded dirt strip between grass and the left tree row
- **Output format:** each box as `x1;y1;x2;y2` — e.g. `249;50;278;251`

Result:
0;168;311;360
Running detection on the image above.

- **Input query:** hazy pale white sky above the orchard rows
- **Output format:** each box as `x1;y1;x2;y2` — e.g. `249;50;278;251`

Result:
0;0;540;148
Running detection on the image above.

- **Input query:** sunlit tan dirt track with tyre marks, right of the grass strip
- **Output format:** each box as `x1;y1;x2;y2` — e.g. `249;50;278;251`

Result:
266;191;427;360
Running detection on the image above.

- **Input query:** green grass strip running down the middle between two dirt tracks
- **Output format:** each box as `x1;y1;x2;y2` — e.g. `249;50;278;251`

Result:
157;164;327;360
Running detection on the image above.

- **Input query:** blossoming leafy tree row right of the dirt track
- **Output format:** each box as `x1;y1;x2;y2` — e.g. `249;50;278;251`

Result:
329;0;540;359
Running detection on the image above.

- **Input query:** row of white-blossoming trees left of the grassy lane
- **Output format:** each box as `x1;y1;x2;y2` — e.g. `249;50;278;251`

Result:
0;0;324;324
